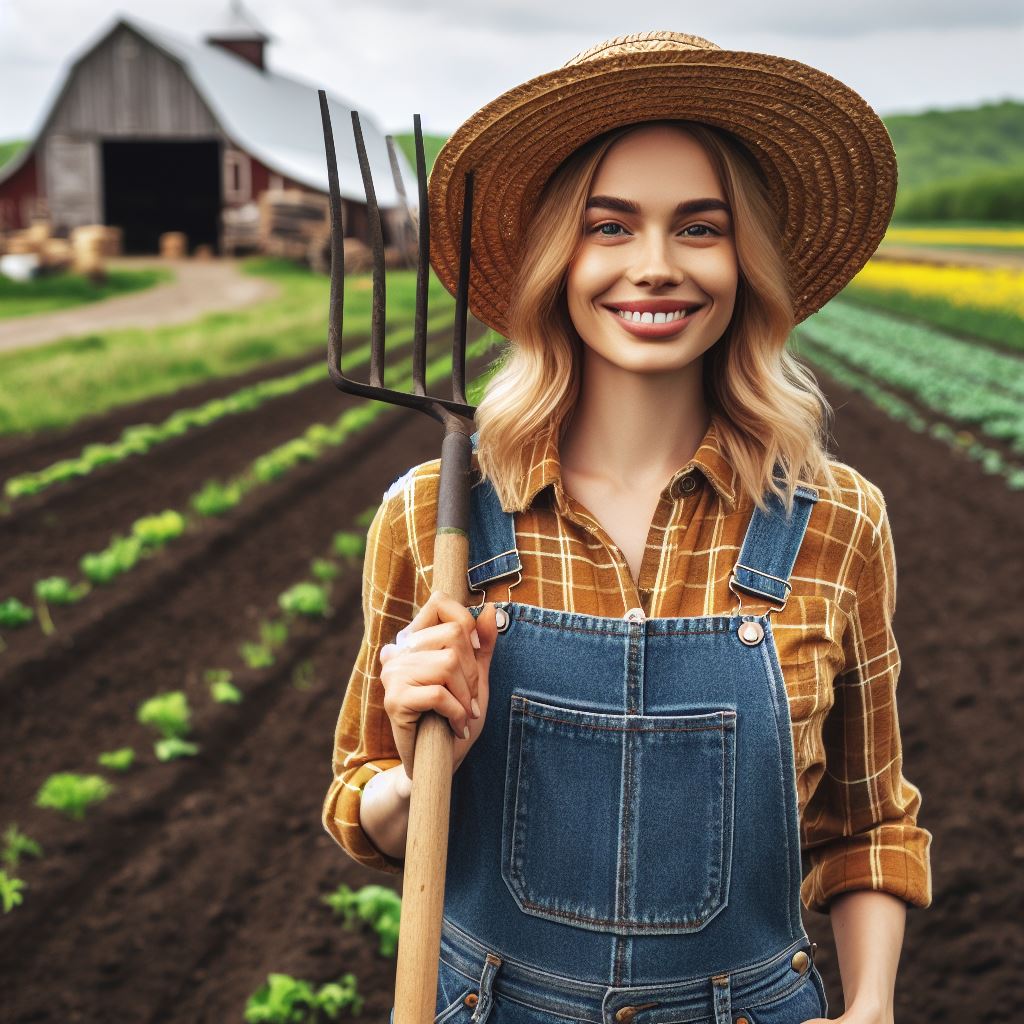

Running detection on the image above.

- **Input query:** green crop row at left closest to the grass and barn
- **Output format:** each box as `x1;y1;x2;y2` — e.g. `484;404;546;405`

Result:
3;309;452;511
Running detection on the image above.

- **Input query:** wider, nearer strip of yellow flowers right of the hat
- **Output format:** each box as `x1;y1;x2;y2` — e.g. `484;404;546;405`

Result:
849;260;1024;317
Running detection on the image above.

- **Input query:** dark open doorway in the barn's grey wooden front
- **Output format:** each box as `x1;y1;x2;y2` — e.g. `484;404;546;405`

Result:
102;140;221;254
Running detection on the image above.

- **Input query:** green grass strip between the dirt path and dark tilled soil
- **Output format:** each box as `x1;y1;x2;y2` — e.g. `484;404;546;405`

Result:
0;257;455;435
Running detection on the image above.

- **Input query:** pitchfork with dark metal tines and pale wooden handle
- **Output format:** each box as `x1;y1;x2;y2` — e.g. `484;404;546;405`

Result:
318;89;476;1024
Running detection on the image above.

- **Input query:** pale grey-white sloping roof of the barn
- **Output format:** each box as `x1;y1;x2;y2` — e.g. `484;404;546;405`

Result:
0;14;419;207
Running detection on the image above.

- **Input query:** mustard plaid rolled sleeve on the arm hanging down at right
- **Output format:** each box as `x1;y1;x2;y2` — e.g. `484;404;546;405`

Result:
801;484;932;913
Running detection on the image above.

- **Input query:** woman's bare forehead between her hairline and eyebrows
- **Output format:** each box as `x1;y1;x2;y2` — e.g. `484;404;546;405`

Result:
590;125;725;196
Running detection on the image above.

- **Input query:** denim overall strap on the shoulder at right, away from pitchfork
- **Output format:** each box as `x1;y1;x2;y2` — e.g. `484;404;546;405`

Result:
729;467;818;610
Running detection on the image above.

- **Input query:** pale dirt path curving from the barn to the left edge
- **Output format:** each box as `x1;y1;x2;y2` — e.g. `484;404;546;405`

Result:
0;256;281;352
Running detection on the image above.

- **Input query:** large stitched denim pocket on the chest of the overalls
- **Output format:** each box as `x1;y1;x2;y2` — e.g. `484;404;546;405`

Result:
502;693;736;935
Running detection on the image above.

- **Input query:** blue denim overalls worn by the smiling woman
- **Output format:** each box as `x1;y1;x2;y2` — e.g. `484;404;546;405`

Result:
392;446;827;1024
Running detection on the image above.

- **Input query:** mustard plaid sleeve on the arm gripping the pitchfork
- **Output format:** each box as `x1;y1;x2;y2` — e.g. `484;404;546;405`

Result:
323;494;417;874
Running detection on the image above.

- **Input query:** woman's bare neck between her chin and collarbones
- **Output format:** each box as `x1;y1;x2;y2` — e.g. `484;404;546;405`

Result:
559;347;711;489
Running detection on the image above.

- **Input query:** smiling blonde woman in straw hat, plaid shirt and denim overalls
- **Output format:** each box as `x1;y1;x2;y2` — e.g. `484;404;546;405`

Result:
324;32;931;1024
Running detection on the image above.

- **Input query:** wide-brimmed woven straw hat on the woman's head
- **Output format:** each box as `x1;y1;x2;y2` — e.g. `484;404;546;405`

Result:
428;32;896;337
